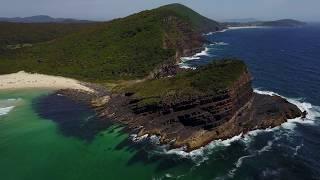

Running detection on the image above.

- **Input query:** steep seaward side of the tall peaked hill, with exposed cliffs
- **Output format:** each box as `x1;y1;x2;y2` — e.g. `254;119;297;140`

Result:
147;4;225;79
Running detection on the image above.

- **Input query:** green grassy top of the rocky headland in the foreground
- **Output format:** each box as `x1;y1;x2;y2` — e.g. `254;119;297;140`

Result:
121;60;247;104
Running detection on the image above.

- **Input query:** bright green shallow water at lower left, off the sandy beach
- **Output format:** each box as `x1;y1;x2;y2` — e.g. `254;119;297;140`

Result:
0;90;164;180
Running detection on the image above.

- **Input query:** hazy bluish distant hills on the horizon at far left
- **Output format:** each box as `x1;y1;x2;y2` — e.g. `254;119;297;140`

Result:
0;15;91;23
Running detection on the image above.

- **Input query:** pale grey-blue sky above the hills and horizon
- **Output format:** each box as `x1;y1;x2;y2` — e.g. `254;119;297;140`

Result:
0;0;320;21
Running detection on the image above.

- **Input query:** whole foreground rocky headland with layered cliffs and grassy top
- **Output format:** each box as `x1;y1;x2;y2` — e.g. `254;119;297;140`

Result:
91;61;302;150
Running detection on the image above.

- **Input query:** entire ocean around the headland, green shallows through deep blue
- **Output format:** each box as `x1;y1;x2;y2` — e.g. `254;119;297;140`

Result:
0;24;320;180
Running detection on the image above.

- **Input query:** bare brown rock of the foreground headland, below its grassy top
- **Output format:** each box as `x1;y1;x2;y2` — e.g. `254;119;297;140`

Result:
92;62;302;150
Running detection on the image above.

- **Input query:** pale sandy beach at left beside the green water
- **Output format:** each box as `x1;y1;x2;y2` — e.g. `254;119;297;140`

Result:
0;71;93;92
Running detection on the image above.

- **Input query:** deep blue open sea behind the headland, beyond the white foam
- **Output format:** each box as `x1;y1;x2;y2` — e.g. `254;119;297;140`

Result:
182;25;320;105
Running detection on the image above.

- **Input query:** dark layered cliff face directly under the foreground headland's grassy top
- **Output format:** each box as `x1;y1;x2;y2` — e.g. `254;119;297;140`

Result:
132;70;253;131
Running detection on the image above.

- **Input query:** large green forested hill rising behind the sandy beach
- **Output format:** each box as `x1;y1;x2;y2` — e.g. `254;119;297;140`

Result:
0;4;221;82
